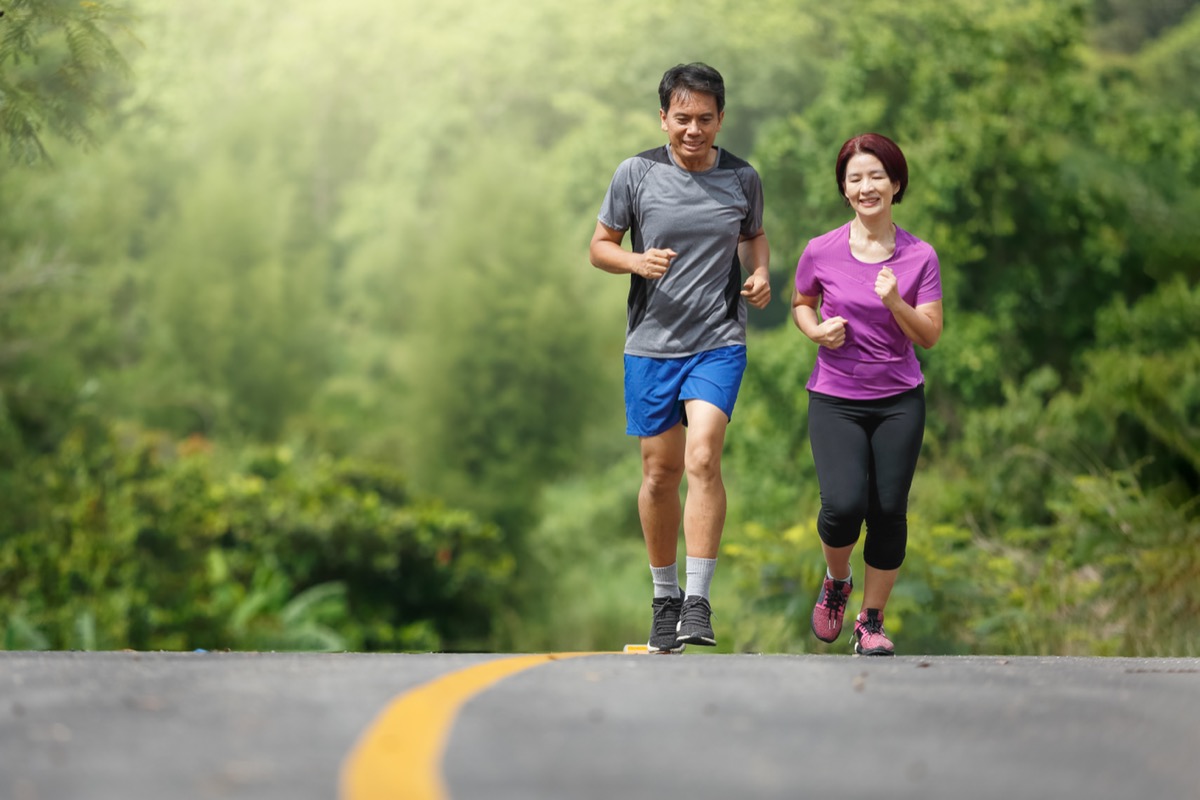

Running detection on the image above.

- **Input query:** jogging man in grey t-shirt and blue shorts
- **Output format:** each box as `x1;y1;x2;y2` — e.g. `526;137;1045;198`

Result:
589;64;770;652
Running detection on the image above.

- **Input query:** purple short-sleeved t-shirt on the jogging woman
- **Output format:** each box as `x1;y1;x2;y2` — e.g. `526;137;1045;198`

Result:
796;222;942;399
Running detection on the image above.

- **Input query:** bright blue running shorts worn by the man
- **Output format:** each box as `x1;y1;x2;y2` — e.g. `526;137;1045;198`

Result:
625;344;746;437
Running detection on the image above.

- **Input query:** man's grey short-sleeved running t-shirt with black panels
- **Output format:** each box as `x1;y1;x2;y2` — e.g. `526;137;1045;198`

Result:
599;145;762;359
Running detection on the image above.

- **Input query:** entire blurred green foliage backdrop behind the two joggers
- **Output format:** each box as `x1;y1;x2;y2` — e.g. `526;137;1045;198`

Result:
0;0;1200;654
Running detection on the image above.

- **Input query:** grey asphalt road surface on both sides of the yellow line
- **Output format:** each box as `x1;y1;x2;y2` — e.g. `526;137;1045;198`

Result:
0;652;1200;800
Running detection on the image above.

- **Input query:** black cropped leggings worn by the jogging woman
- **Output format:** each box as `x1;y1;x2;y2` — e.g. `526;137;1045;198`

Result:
809;386;925;570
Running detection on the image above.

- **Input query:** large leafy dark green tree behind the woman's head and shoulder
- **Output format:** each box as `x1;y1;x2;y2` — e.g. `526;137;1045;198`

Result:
763;0;1189;403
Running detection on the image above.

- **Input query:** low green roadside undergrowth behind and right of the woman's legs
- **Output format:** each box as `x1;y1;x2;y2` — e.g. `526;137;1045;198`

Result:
705;247;1200;655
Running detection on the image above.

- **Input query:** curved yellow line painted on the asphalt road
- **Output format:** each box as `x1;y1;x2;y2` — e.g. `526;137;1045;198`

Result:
338;652;595;800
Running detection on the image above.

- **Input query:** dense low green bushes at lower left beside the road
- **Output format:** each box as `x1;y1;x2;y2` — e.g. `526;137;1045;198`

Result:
0;428;514;650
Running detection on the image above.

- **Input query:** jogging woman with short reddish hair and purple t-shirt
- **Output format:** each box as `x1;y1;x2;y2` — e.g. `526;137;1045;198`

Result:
792;133;942;656
